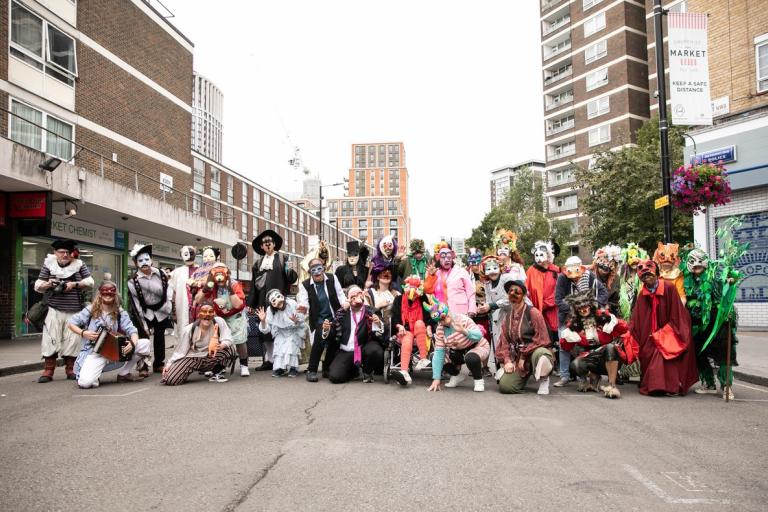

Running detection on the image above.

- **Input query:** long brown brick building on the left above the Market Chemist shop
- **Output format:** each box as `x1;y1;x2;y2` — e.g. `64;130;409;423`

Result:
0;0;346;338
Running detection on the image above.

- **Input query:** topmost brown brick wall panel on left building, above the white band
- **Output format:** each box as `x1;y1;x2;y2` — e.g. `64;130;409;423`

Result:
77;0;192;104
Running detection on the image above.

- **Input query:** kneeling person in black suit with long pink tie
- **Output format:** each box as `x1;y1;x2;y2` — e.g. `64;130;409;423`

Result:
326;286;384;384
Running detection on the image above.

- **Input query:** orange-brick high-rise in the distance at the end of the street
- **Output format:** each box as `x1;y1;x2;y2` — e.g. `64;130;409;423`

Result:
328;142;411;248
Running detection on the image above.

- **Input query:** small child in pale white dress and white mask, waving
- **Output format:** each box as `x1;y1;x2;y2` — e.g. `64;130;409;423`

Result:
256;289;307;377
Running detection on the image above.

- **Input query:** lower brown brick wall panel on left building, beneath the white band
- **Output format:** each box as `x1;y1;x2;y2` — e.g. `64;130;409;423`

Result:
75;45;192;166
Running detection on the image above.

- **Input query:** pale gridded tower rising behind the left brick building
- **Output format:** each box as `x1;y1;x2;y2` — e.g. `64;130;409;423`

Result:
192;71;224;162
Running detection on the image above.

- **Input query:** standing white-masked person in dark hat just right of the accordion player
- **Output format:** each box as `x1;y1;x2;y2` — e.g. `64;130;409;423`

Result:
128;244;173;376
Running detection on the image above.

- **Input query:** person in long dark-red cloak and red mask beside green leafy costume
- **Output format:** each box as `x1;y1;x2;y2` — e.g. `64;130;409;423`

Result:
629;260;698;395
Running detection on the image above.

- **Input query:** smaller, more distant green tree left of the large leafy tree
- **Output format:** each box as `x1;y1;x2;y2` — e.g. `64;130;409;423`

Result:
466;167;572;265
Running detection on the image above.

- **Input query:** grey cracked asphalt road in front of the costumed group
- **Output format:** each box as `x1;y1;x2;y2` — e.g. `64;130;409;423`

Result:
0;372;768;512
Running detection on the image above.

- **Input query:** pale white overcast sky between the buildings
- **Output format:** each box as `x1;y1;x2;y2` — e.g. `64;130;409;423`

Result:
159;0;544;248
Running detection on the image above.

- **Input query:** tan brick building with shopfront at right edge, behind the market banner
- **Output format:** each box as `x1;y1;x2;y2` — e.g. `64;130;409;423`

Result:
646;0;768;329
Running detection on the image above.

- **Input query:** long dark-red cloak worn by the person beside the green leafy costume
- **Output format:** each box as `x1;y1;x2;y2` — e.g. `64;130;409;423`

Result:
629;279;698;395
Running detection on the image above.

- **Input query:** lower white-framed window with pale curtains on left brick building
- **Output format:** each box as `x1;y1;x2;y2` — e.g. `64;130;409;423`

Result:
10;100;74;161
